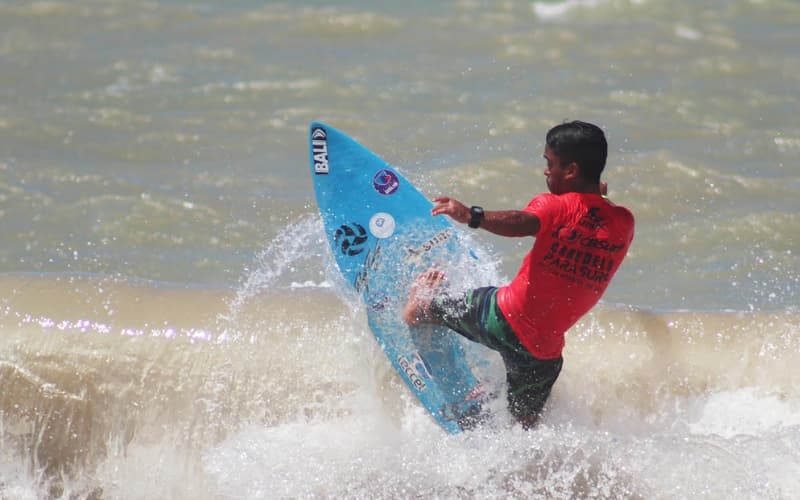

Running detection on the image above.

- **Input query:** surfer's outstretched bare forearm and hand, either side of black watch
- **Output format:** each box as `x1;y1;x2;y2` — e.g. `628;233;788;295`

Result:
431;196;540;237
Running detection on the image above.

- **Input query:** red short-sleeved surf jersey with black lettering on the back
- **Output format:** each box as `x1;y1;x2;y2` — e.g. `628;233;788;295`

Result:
497;193;633;359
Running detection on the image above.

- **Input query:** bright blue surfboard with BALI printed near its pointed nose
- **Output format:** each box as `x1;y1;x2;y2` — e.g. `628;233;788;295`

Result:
309;122;486;433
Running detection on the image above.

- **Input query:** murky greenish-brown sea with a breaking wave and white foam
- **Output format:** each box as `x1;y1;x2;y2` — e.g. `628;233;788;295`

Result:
0;0;800;499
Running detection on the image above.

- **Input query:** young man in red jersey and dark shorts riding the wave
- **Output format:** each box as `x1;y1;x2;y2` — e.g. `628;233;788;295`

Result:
404;121;634;428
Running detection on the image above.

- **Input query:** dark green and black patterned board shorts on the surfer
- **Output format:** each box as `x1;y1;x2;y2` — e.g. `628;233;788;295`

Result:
429;287;563;421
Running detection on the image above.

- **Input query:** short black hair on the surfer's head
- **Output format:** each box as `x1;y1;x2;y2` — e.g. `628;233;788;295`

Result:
547;120;608;183
